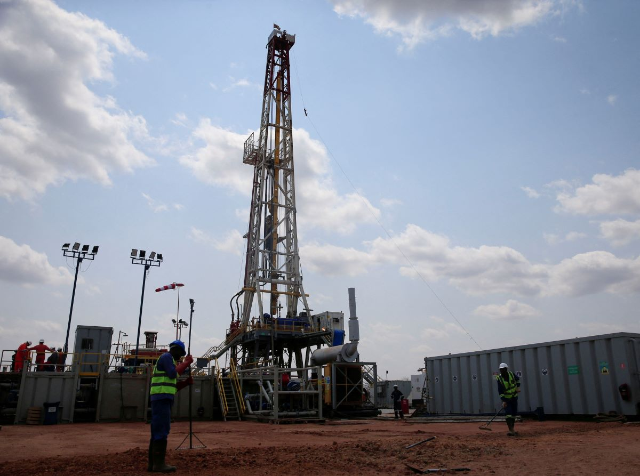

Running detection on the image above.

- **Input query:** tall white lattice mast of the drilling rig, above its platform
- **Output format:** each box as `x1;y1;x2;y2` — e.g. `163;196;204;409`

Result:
241;25;310;327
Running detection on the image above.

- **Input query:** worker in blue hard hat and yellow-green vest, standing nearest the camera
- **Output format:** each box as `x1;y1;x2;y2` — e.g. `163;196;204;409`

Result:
148;340;193;473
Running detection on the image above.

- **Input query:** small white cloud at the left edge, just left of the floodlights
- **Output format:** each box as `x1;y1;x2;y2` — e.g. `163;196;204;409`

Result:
0;236;74;286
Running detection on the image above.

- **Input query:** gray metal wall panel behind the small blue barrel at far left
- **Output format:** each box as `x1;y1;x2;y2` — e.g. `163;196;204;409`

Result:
15;372;76;423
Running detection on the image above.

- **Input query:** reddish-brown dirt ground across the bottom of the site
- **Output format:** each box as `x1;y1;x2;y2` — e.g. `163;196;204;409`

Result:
0;420;640;476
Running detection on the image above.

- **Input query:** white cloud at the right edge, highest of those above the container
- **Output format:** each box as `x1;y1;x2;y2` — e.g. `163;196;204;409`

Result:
556;169;640;215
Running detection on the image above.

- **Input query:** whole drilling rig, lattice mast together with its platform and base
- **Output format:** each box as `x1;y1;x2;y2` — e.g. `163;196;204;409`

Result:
203;25;375;418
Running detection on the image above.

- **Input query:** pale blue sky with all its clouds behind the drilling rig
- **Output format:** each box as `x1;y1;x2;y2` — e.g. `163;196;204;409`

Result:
0;0;640;379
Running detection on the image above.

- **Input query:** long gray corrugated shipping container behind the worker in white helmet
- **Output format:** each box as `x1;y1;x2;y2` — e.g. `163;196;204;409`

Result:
425;333;640;415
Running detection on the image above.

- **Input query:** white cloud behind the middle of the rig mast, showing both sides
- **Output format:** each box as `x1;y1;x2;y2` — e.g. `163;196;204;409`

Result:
180;119;380;234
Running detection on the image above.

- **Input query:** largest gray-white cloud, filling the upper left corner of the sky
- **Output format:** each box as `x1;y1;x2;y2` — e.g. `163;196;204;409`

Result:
0;0;154;199
